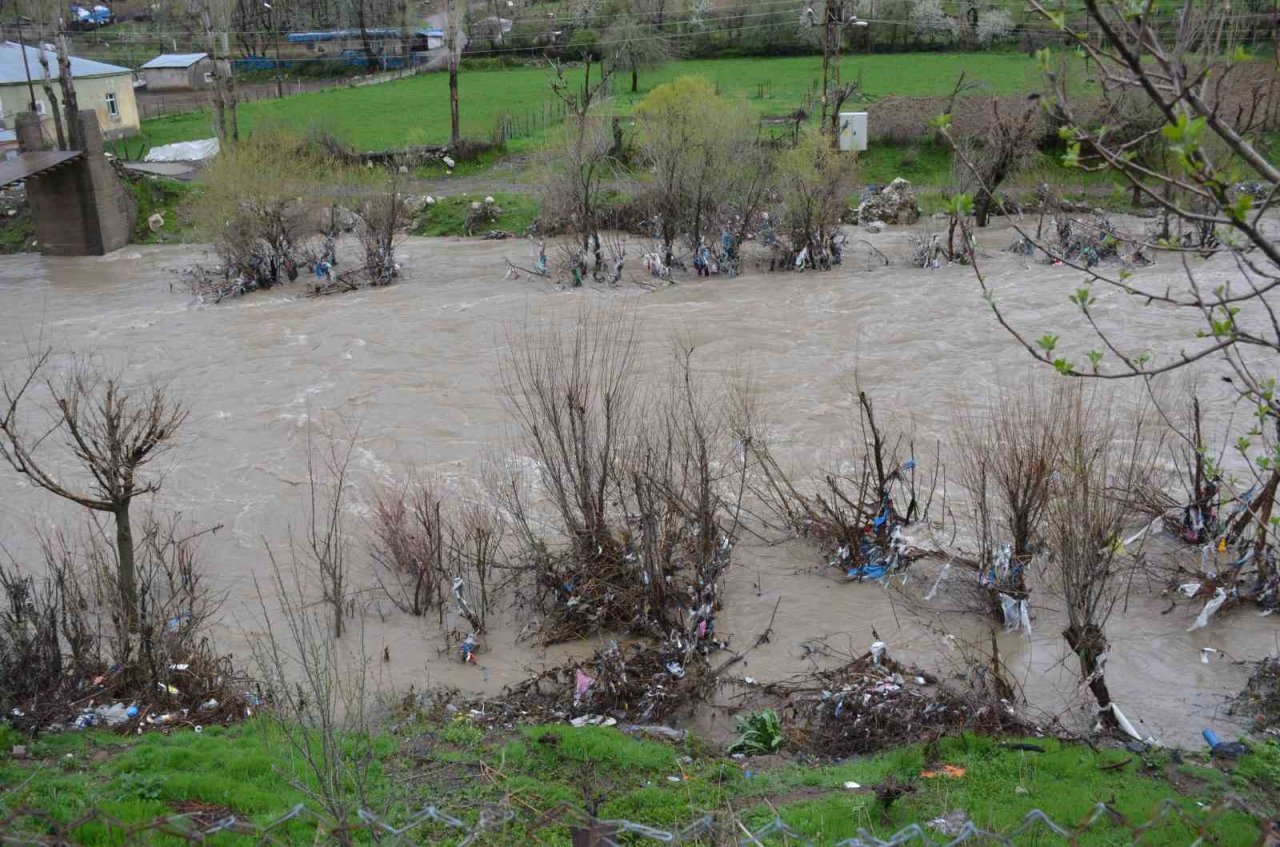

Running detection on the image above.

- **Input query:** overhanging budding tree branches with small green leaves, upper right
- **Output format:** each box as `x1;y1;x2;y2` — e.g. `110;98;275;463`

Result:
974;0;1280;591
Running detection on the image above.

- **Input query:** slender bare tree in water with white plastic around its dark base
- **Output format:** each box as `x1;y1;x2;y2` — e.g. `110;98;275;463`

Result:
1046;386;1160;728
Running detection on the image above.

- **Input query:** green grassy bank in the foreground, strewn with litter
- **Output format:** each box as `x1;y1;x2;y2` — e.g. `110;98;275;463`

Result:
0;719;1280;844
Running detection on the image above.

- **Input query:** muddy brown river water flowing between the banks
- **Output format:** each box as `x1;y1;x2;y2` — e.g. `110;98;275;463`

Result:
0;230;1280;745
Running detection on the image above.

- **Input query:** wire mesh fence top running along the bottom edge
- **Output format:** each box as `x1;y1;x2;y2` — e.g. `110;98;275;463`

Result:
0;795;1264;847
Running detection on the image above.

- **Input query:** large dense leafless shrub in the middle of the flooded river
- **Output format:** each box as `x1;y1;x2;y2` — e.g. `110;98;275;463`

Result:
502;312;731;641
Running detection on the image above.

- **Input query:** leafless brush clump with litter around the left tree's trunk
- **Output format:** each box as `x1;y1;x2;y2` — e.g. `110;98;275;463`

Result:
0;514;243;731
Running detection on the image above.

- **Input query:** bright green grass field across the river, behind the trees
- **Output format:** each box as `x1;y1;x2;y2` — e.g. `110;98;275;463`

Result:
135;52;1064;150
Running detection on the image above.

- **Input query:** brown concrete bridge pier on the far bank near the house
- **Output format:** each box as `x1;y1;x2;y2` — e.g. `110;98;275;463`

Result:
17;109;137;256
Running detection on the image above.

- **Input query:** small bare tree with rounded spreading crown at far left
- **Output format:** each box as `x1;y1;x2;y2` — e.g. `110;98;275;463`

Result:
0;351;187;624
